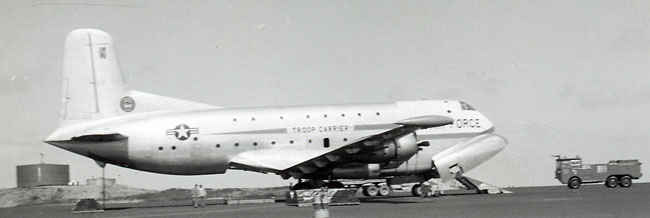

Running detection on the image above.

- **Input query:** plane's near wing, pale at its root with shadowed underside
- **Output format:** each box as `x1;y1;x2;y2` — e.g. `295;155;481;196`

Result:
230;115;453;177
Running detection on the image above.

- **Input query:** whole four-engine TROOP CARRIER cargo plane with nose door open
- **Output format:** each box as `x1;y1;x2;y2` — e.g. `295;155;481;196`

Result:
44;29;507;195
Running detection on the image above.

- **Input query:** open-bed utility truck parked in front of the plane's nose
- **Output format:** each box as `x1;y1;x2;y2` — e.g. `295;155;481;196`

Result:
554;155;642;189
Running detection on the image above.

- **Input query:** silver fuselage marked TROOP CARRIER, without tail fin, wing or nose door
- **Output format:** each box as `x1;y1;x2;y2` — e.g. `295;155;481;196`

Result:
46;100;493;175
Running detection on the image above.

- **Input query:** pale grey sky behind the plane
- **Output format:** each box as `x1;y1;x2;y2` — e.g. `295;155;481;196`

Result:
0;0;650;189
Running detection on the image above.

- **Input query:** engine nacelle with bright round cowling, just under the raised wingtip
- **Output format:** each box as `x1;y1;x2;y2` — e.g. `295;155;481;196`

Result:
358;133;418;163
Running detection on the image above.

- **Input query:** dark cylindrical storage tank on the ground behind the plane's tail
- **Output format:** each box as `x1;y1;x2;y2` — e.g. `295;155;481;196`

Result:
16;164;70;188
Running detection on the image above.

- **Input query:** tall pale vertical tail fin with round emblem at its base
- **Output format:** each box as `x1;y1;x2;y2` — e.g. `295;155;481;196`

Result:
61;29;214;125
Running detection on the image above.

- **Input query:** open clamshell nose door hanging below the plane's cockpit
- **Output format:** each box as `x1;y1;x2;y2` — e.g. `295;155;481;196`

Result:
432;134;508;180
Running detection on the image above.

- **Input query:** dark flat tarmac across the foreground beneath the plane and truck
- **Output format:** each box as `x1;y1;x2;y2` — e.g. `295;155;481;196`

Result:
0;183;650;218
